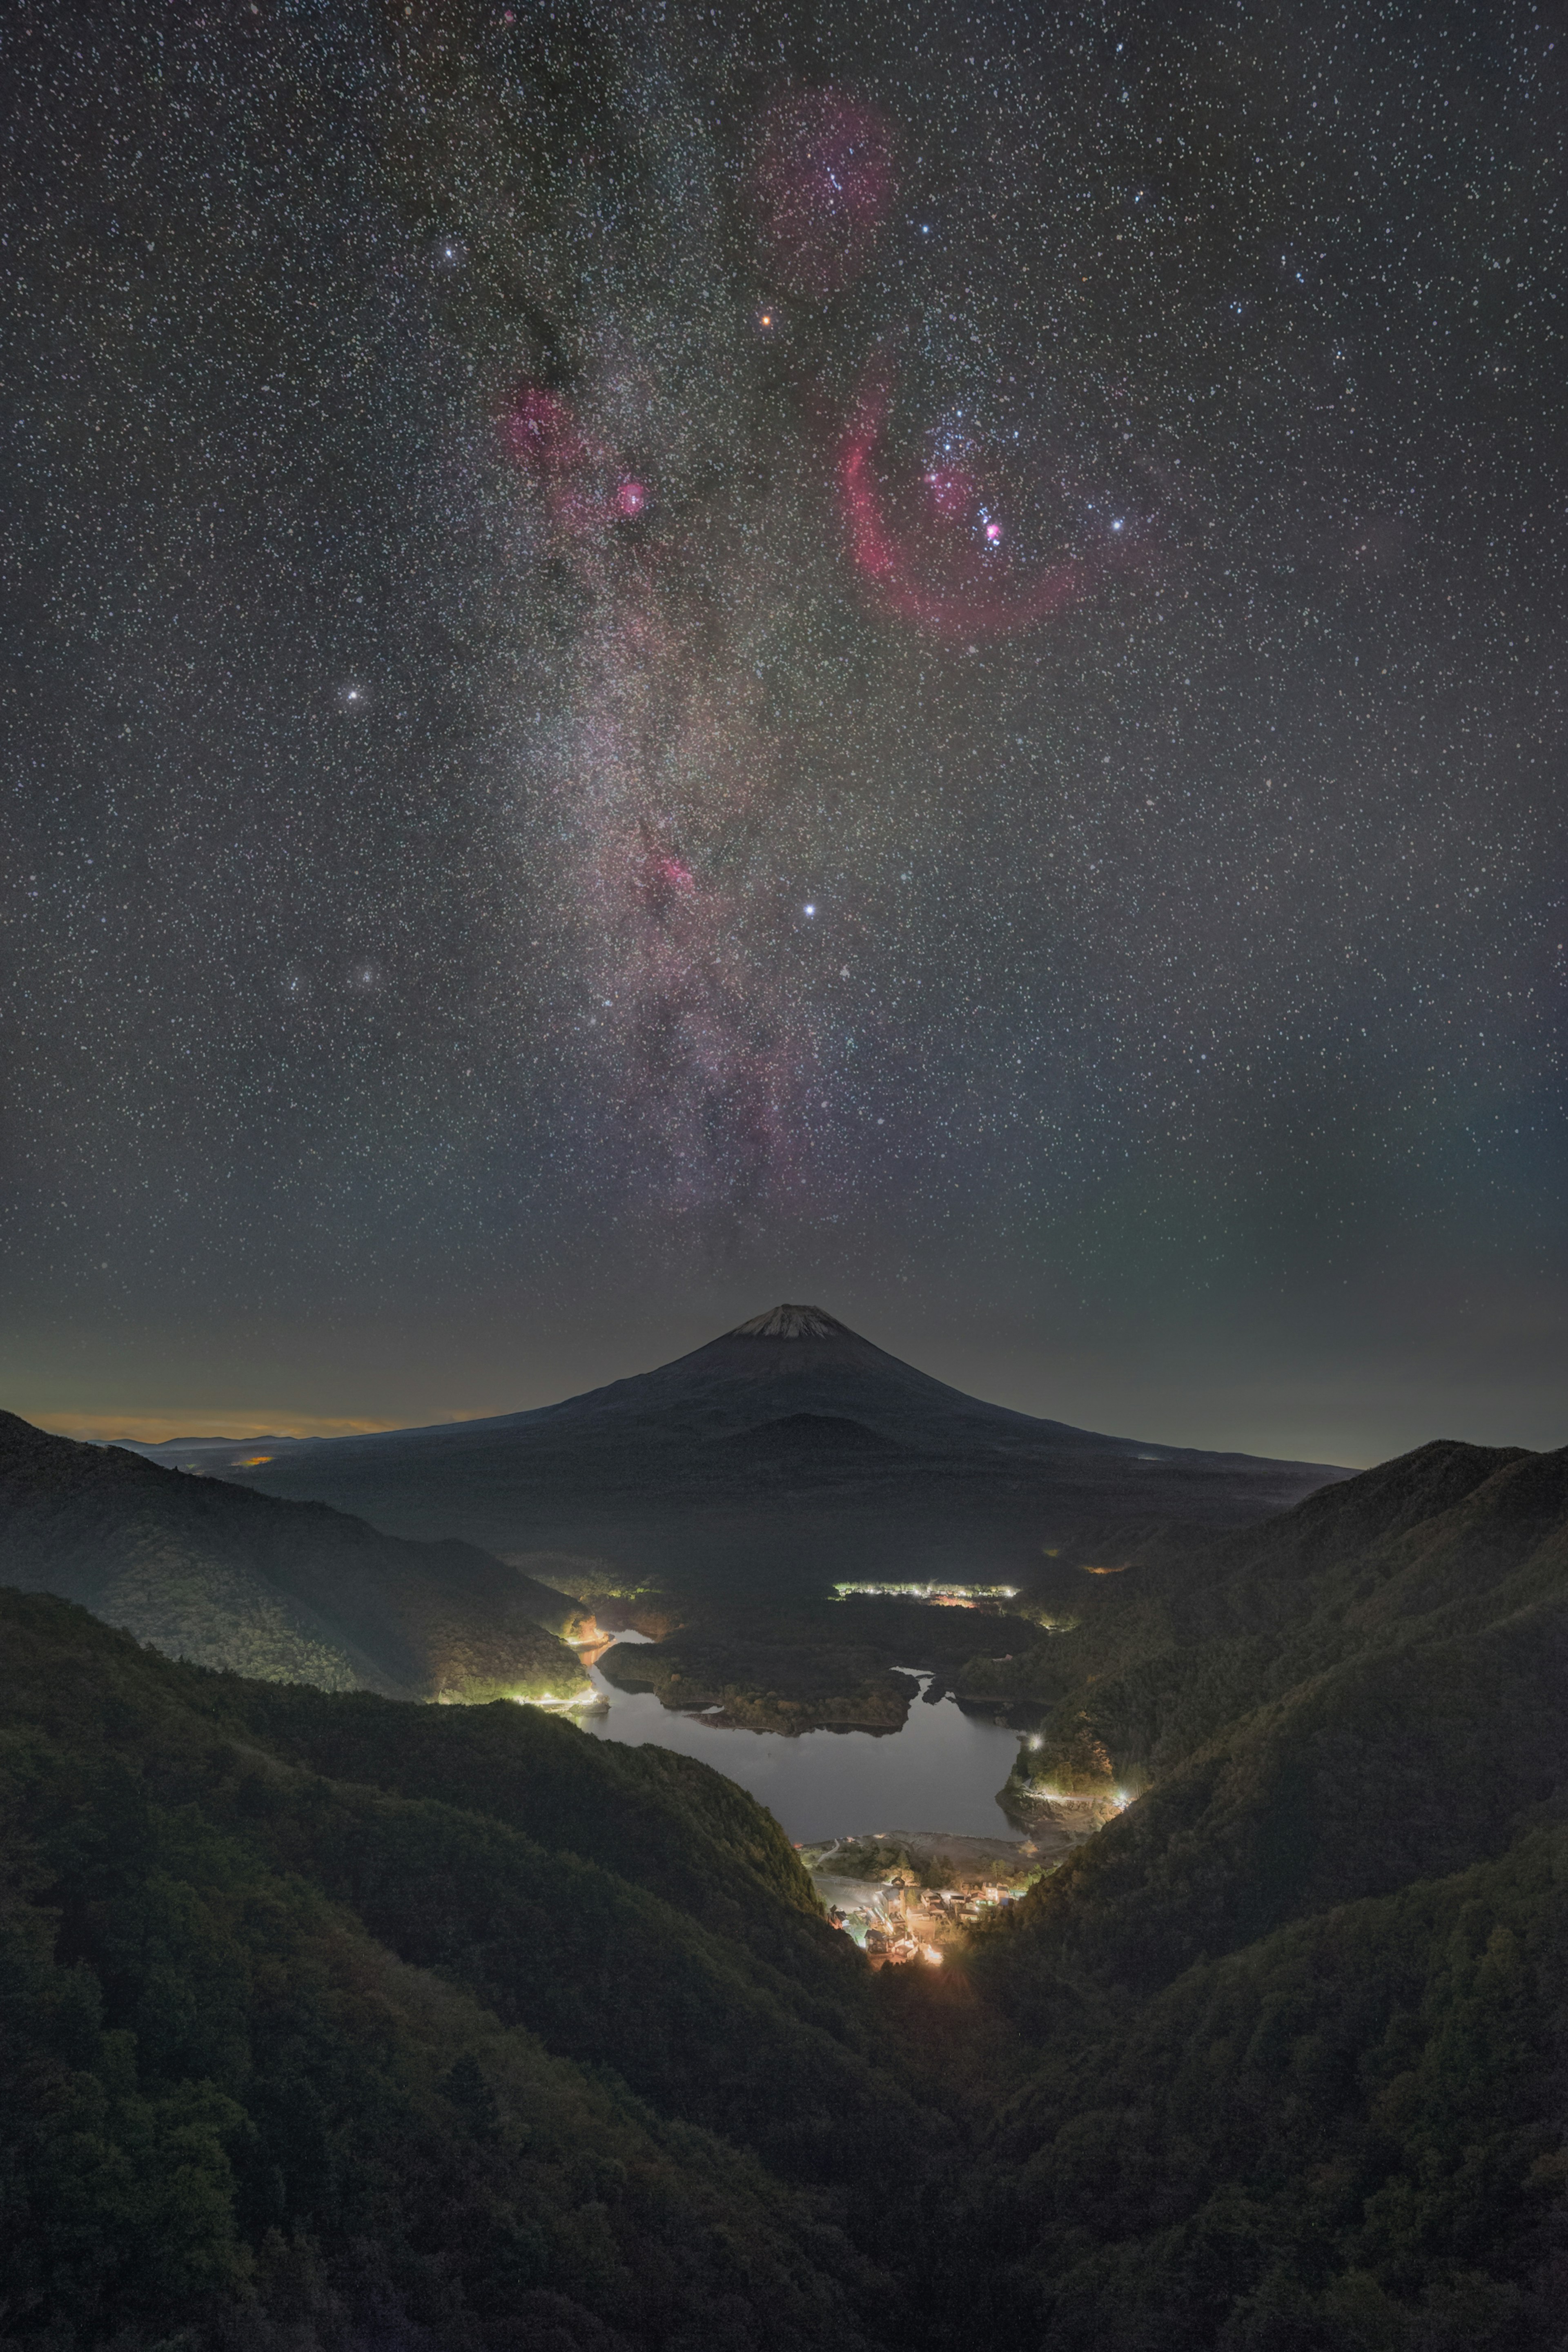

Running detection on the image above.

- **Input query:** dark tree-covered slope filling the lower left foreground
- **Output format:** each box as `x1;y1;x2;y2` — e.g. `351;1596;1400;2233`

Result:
0;1592;933;2352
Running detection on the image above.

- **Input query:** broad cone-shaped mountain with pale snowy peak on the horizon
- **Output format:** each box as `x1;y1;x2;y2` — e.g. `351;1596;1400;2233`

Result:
126;1308;1345;1602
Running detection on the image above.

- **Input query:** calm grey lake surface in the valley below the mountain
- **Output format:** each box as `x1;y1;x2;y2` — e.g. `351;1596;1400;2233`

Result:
583;1637;1018;1844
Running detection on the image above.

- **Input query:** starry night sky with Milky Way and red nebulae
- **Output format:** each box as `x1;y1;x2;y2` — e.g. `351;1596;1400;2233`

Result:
0;0;1568;1463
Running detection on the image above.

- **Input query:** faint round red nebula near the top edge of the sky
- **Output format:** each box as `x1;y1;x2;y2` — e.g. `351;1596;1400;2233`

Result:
752;89;895;301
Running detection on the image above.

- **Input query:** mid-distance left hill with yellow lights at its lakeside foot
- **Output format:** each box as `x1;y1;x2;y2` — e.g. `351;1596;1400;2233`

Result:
0;1414;588;1698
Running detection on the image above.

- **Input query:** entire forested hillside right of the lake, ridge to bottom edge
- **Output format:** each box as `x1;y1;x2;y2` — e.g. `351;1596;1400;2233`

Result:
969;1444;1568;2352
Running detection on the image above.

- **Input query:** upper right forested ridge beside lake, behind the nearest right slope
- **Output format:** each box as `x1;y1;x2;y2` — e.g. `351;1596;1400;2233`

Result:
982;1444;1568;1990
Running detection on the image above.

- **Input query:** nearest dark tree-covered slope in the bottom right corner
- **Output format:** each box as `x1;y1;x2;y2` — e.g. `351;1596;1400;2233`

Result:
952;1818;1568;2352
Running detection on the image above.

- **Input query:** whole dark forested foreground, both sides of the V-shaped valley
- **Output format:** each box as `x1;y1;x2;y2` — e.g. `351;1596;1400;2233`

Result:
0;1411;1568;2352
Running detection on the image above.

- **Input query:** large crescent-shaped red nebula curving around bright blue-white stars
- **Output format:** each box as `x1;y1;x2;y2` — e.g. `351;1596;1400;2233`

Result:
839;369;1084;637
